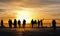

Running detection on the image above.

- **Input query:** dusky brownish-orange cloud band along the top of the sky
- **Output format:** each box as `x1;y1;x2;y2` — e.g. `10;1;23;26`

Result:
0;0;60;7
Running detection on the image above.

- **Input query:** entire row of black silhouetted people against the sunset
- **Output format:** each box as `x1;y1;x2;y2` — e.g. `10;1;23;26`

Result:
1;19;56;29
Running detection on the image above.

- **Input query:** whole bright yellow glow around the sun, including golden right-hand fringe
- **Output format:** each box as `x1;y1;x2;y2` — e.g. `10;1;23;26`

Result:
16;8;43;23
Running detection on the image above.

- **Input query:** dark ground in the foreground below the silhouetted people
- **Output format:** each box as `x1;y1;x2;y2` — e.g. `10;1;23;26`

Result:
0;28;60;36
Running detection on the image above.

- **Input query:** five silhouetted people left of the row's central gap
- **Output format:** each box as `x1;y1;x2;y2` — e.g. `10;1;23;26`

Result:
0;19;26;28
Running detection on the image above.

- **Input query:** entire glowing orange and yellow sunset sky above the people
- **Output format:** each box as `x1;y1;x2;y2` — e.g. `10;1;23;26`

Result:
0;0;60;22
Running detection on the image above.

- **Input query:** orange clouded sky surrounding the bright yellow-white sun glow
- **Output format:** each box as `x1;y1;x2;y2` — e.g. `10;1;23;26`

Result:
0;0;60;18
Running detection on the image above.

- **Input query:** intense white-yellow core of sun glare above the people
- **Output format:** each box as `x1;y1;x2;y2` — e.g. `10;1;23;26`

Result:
17;9;31;23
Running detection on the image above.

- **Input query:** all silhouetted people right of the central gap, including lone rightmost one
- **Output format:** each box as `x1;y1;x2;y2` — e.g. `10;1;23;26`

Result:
31;19;56;30
